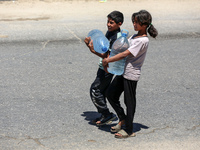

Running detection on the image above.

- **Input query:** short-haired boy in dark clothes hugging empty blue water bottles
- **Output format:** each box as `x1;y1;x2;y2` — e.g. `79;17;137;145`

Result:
85;11;124;125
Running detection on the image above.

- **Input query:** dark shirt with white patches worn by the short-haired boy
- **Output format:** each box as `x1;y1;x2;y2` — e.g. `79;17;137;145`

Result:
99;28;121;70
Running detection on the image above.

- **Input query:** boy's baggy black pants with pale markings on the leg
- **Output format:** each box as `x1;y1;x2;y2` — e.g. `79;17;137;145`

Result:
90;68;113;116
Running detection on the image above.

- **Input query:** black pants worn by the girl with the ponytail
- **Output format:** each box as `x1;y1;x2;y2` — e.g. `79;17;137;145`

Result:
106;76;137;135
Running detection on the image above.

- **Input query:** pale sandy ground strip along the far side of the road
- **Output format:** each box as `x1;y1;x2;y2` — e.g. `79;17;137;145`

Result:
0;0;200;21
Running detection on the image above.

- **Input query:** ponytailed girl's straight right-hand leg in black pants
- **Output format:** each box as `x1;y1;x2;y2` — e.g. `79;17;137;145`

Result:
124;79;137;135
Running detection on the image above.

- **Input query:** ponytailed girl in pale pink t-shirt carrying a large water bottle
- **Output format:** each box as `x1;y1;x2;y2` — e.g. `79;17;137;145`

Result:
103;10;158;138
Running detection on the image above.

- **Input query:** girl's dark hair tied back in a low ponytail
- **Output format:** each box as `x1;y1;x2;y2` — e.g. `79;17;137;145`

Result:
132;10;158;38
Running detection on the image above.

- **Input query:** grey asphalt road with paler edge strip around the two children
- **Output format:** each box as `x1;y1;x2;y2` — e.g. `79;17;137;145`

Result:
0;0;200;150
